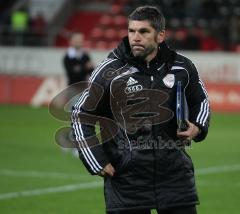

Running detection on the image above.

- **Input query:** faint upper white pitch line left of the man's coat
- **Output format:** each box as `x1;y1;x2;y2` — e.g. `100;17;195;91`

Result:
0;169;89;180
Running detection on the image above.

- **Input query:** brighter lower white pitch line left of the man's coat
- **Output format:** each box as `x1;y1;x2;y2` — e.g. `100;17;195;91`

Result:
0;181;102;200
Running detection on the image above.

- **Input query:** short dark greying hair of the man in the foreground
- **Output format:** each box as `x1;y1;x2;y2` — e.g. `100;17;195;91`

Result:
128;6;165;32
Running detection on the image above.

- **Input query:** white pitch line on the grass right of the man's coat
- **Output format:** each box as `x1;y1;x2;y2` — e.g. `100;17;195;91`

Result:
196;164;240;175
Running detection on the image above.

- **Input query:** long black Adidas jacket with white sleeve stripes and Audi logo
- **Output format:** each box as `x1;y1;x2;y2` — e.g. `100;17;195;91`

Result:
72;38;210;211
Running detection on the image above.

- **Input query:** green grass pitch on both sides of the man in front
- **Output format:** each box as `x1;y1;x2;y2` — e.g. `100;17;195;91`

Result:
0;106;240;214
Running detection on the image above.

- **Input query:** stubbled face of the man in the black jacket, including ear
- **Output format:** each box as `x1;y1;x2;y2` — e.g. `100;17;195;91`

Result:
128;20;164;61
